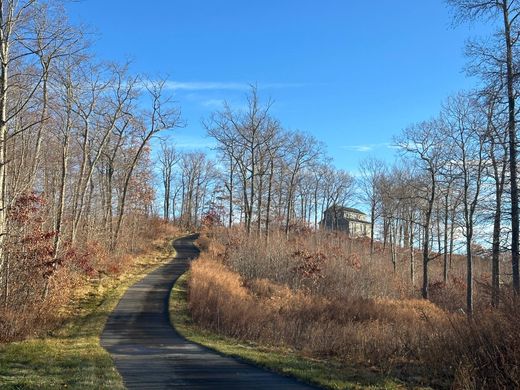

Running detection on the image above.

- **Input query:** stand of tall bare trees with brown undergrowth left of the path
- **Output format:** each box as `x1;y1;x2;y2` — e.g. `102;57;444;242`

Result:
0;0;180;342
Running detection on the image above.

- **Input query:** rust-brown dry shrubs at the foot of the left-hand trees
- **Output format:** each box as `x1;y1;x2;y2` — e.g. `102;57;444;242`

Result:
0;213;177;342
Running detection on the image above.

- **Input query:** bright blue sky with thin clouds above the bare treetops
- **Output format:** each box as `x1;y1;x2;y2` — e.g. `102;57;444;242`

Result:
67;0;488;173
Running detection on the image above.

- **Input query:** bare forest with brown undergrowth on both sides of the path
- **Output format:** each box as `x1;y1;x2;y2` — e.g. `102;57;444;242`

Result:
0;0;520;388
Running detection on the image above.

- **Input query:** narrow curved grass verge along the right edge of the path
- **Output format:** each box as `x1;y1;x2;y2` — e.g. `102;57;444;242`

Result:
170;273;406;389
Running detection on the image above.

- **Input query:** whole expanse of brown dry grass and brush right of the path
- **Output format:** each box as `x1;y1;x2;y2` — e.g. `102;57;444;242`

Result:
189;232;520;389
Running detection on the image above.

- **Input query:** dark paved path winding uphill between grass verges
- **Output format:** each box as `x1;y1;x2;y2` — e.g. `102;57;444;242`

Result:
101;236;311;389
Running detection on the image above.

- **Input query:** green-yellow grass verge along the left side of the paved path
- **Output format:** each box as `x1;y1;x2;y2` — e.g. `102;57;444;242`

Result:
0;239;174;389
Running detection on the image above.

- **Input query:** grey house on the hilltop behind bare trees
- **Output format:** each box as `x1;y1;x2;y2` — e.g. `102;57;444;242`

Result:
320;205;371;237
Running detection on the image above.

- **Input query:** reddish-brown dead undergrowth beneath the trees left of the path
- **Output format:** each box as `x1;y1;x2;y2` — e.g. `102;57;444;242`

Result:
0;220;178;342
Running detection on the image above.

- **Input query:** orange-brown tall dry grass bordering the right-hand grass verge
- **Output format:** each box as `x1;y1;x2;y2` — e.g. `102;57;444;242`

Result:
189;257;446;364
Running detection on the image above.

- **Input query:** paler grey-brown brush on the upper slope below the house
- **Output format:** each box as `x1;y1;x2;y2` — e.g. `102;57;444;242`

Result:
212;230;496;311
